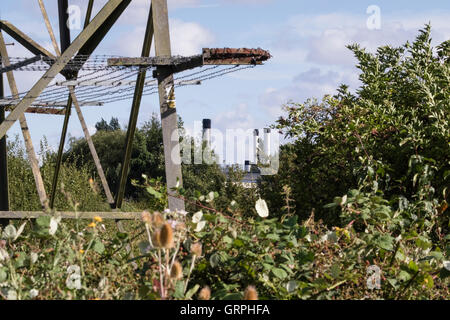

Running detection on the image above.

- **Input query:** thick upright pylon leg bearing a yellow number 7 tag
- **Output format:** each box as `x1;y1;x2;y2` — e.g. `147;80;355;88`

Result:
152;0;185;211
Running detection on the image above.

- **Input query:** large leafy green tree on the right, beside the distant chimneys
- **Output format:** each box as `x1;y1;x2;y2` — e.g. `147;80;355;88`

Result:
263;26;450;228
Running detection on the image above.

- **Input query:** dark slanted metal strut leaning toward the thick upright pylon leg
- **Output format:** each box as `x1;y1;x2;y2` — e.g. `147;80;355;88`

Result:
115;6;153;208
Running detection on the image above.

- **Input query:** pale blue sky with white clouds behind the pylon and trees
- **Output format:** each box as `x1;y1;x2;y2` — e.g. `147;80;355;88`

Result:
0;0;450;164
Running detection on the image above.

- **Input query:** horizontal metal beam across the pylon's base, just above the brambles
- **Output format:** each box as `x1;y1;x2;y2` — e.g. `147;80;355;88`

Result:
0;210;142;220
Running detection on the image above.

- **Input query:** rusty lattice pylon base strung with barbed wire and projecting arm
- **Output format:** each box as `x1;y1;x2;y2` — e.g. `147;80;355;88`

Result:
0;0;271;222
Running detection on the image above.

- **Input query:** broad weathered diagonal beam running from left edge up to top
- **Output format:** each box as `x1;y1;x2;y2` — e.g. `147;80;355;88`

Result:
0;0;131;138
